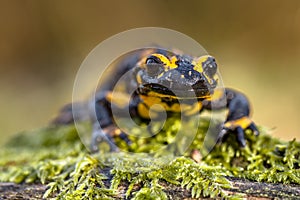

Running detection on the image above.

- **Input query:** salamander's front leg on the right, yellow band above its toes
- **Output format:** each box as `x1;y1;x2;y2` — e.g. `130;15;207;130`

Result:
218;88;259;147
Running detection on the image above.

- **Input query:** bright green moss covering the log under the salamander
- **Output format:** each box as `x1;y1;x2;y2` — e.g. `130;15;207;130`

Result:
0;118;300;199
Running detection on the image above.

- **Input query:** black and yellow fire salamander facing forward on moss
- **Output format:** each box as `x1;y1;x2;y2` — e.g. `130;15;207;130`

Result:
55;48;259;151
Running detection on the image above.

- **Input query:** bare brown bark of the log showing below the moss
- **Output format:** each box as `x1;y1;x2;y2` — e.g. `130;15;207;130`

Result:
0;176;300;199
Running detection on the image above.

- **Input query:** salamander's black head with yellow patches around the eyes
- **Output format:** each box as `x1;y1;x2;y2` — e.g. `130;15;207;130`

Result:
136;50;218;98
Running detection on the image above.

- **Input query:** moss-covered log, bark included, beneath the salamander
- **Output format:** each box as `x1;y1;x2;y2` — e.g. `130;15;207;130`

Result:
0;121;300;199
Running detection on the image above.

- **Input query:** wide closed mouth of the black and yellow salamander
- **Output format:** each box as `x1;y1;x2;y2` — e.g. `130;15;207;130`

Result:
138;83;211;99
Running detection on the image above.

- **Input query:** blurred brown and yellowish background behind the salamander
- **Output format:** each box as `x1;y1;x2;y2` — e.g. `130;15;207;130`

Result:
0;0;300;143
